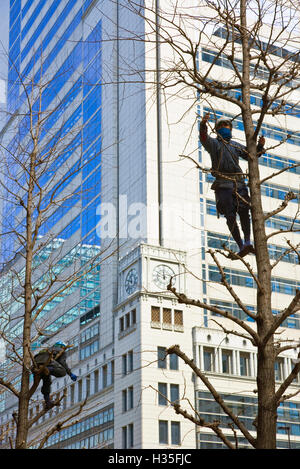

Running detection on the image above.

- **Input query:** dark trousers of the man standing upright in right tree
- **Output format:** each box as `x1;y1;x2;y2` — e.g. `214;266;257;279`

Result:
215;185;251;249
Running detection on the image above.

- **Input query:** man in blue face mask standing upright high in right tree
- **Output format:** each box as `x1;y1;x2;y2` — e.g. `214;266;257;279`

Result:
200;113;265;259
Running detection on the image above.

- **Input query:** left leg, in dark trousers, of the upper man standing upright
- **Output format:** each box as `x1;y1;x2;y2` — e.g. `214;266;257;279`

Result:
215;188;246;250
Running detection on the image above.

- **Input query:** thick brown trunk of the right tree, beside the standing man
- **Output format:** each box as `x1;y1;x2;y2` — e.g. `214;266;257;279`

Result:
240;0;277;449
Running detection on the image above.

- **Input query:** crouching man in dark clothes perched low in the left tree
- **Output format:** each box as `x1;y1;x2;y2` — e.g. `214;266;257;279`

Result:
33;342;77;409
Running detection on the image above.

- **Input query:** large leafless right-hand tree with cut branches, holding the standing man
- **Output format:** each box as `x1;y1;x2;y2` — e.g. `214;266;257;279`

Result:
111;0;300;449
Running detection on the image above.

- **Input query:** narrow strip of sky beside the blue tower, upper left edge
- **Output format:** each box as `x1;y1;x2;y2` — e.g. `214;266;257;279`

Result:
0;0;9;104
